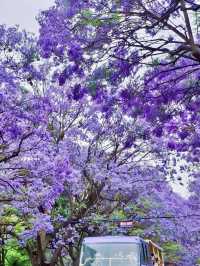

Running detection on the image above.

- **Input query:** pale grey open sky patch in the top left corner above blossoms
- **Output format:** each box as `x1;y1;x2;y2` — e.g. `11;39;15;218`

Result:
0;0;54;33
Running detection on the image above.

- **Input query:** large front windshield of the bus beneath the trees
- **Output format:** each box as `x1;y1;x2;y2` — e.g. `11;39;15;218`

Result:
80;243;140;266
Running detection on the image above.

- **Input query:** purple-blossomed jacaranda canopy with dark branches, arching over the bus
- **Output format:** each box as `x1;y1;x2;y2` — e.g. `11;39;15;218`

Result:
0;0;200;266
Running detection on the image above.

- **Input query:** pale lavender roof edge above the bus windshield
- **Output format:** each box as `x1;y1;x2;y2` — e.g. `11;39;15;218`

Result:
83;236;142;244
